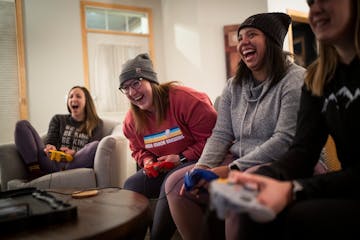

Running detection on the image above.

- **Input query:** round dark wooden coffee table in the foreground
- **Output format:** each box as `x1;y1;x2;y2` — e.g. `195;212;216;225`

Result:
1;188;149;239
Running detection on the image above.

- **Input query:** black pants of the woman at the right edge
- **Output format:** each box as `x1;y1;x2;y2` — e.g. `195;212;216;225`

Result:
226;199;360;240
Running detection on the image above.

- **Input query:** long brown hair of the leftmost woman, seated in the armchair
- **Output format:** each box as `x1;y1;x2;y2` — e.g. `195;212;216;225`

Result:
66;86;101;137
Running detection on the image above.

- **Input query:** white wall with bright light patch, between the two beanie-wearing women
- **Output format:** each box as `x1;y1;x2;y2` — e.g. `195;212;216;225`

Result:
162;0;267;100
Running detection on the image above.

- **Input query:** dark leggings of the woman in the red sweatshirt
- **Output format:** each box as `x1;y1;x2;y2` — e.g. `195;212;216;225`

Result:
124;163;191;240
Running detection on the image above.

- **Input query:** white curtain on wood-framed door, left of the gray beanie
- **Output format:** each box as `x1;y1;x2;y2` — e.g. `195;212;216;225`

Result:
88;33;149;119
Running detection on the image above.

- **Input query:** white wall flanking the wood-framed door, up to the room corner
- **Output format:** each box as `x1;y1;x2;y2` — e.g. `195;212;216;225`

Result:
22;0;164;132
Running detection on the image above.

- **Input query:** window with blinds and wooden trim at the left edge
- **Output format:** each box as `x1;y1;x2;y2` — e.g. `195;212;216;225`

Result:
0;0;28;144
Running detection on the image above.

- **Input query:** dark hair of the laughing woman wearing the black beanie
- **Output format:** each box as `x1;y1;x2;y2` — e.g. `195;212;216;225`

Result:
234;35;291;86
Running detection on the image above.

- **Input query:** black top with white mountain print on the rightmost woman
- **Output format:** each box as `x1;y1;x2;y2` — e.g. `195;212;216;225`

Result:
257;58;360;198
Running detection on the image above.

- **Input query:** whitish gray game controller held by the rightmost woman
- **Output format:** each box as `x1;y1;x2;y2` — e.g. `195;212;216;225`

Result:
209;179;276;222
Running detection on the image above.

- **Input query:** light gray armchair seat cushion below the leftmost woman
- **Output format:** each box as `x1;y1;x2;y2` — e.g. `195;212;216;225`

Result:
7;168;96;190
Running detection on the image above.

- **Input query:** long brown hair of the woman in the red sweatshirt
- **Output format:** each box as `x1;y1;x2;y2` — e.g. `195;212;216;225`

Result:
130;81;178;133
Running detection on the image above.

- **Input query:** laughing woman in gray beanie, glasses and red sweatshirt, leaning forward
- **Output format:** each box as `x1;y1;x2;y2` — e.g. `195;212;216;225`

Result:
119;54;217;239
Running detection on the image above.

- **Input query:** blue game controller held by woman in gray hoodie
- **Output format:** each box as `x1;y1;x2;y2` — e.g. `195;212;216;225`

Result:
184;168;219;191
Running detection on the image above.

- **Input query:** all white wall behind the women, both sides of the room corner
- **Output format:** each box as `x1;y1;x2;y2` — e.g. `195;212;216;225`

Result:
14;0;308;142
